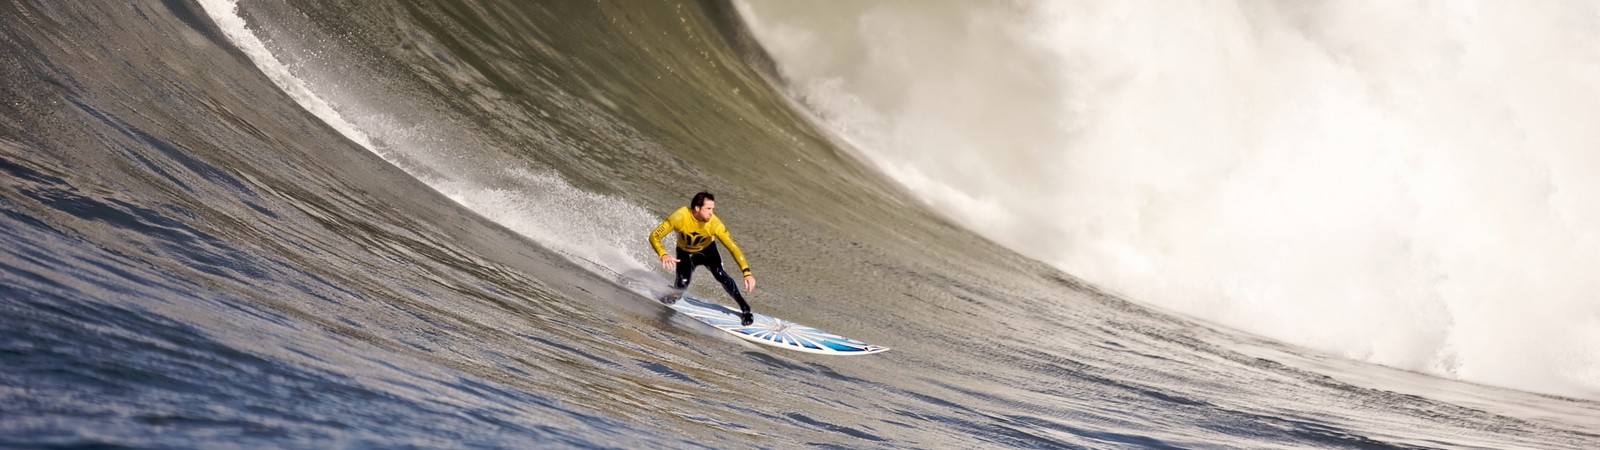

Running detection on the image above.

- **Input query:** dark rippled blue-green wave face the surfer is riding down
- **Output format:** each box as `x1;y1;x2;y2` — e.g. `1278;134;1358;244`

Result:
0;0;1600;448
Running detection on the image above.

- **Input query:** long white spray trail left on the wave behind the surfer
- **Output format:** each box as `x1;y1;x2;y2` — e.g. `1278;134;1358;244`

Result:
200;0;659;283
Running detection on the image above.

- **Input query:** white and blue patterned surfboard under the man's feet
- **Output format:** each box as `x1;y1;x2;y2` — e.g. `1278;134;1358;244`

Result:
667;295;890;356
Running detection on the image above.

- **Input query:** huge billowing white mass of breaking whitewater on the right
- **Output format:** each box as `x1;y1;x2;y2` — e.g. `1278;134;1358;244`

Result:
744;2;1600;399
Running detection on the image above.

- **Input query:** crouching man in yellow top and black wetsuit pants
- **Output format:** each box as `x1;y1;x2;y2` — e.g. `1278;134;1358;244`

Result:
650;192;755;325
